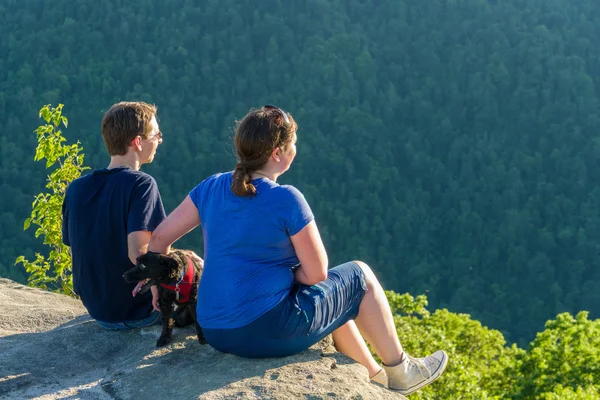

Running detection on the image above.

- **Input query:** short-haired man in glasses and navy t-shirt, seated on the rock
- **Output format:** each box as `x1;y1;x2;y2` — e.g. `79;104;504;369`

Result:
62;102;166;330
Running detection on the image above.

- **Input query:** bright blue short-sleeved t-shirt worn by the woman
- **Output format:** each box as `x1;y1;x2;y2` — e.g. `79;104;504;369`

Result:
190;172;314;329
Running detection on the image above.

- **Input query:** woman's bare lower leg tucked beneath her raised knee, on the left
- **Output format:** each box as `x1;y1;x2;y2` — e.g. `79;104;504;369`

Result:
332;321;381;377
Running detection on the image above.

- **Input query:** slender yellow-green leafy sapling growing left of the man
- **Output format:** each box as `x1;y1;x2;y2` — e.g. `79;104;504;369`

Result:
15;104;89;296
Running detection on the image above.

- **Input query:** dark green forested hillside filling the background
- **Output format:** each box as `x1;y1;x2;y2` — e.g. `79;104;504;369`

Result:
0;0;600;344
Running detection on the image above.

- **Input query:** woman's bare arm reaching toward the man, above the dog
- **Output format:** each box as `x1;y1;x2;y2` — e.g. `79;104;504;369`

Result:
148;195;200;254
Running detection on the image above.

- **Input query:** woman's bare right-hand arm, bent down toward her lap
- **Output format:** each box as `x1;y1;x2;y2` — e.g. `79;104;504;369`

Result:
291;220;329;285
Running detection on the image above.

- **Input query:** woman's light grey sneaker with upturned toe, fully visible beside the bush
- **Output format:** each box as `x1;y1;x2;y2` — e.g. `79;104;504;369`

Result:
383;350;448;394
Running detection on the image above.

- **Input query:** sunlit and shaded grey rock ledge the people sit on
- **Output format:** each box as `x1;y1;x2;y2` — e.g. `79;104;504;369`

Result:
0;278;404;400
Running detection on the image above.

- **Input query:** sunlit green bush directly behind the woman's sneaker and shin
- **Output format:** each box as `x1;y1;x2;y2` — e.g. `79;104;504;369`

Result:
386;291;525;400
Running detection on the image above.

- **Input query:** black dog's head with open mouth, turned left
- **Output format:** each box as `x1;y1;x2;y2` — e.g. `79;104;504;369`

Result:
123;252;185;296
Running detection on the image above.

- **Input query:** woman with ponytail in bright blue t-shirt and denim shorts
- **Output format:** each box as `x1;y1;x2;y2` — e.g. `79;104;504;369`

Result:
149;106;448;394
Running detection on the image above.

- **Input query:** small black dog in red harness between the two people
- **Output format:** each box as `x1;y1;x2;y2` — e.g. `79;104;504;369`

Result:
123;250;206;347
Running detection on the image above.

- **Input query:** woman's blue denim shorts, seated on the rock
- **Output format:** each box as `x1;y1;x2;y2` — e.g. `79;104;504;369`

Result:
202;262;367;358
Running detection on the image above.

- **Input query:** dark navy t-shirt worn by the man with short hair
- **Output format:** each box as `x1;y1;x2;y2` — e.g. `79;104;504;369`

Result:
62;167;166;322
